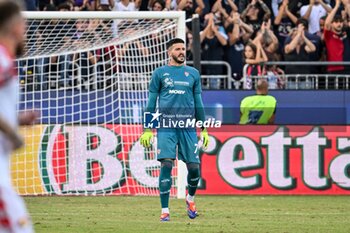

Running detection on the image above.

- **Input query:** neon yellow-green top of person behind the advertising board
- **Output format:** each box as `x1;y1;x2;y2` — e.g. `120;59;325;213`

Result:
239;95;277;124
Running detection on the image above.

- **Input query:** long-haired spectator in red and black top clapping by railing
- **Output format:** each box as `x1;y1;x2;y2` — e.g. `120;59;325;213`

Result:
244;38;268;89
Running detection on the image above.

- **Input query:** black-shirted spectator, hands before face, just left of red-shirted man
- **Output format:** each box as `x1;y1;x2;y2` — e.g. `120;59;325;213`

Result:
284;24;316;88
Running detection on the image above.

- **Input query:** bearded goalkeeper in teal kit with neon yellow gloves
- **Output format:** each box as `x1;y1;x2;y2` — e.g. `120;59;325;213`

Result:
141;38;209;221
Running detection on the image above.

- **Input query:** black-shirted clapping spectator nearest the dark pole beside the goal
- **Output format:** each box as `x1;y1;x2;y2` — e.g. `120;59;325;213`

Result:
200;13;227;89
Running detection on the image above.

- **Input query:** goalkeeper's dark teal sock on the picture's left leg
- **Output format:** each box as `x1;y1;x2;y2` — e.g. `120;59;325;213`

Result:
159;160;173;208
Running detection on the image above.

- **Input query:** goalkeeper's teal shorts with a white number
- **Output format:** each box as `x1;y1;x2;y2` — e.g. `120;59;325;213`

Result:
157;128;200;163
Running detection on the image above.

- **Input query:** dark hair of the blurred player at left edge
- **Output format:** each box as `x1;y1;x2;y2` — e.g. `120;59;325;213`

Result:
0;0;23;31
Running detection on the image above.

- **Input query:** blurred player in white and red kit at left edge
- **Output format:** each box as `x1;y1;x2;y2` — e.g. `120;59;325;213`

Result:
0;0;36;233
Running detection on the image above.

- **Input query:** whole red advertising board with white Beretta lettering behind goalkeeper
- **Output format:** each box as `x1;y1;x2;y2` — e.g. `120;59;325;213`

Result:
34;125;350;195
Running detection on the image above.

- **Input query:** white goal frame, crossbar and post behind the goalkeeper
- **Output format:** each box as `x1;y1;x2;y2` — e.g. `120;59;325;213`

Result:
20;11;187;199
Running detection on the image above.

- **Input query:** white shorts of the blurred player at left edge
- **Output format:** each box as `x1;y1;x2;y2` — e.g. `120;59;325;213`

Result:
0;154;34;233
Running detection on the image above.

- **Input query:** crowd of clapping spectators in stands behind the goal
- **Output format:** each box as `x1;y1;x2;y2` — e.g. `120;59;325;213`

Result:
21;0;350;89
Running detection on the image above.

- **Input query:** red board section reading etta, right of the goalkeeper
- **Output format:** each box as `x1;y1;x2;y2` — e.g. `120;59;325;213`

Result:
198;126;350;195
